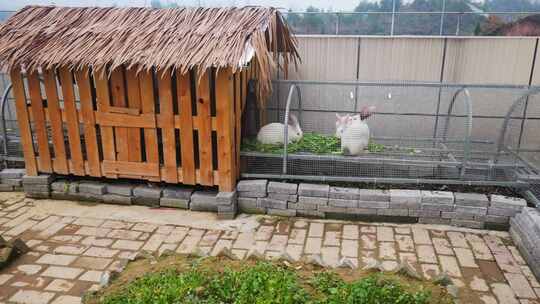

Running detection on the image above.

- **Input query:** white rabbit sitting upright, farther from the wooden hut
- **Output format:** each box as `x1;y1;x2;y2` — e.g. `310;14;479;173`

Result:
341;106;375;155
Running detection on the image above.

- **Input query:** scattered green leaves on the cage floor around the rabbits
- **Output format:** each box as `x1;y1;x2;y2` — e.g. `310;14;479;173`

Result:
242;133;385;154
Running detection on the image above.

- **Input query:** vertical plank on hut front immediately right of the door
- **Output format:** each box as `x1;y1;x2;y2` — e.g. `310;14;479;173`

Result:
158;69;178;183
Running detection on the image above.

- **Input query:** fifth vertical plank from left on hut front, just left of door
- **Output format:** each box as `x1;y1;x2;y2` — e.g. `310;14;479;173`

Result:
75;67;101;177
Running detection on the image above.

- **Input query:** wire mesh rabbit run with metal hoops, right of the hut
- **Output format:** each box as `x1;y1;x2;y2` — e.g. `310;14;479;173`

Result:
241;80;540;187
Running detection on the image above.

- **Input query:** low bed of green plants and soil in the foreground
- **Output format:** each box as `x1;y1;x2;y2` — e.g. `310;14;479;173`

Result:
85;257;452;304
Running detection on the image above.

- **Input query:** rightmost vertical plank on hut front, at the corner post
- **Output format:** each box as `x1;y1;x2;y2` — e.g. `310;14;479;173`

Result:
216;68;236;191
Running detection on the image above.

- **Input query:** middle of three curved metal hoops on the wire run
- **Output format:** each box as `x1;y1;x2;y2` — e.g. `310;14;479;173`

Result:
443;87;473;177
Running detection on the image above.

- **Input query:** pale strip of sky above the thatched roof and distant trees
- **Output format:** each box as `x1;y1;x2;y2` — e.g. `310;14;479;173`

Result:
0;0;376;11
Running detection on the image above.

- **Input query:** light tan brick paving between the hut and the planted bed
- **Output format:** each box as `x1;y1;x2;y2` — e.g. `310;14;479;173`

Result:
0;193;540;304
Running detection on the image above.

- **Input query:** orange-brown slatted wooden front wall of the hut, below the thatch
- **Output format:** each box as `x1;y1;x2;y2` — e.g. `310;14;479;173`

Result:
11;67;255;191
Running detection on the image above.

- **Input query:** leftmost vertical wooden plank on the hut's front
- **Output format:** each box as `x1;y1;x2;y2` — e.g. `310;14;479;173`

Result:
10;67;37;175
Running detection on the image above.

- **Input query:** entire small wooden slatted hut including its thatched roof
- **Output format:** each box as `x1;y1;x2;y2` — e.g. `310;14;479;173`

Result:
0;6;298;191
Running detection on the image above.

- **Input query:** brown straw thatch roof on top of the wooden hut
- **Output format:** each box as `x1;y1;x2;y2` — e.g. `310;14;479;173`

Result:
0;6;298;97
